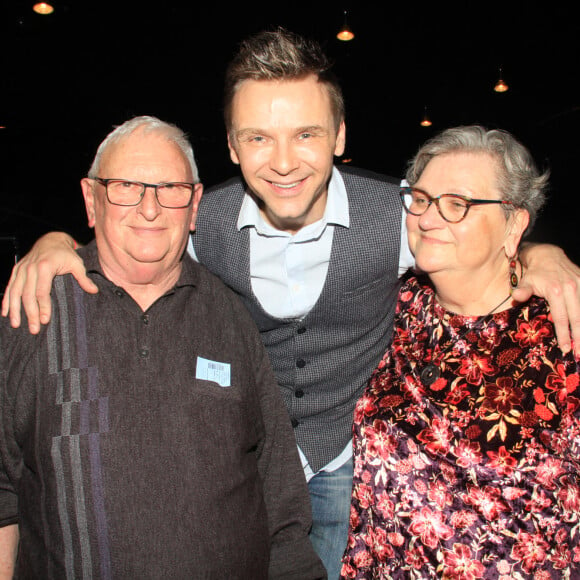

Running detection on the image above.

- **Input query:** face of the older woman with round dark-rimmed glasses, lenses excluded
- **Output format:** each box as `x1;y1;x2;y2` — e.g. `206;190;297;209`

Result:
407;152;527;281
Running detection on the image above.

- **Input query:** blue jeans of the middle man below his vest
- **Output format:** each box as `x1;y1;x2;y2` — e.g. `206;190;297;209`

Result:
308;458;353;580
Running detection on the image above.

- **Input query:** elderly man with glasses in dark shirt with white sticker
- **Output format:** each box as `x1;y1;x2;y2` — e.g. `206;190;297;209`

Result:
0;117;325;579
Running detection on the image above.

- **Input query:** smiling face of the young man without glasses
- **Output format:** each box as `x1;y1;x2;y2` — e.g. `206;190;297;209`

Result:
228;76;345;233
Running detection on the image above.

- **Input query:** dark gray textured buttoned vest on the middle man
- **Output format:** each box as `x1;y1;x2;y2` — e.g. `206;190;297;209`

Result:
193;168;402;472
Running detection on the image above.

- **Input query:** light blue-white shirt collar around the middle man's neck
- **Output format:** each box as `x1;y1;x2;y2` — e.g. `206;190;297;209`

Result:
237;167;350;236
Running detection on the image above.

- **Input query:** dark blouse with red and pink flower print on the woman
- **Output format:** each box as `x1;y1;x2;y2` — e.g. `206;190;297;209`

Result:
342;278;580;580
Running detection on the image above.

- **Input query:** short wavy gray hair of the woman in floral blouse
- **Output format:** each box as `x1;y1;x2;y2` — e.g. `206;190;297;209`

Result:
406;125;550;233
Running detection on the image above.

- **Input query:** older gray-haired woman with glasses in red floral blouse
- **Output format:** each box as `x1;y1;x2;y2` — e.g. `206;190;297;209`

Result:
342;126;580;579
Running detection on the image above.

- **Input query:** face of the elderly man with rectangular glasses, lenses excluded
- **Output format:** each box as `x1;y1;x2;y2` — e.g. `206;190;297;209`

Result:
82;130;203;282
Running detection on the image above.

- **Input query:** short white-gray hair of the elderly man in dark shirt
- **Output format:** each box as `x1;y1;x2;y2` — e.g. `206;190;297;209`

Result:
88;115;199;183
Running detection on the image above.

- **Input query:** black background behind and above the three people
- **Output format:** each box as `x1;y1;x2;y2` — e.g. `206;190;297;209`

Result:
0;0;580;287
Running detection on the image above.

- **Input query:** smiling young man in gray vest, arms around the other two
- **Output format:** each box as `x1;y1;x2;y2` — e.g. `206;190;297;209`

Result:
3;29;580;578
